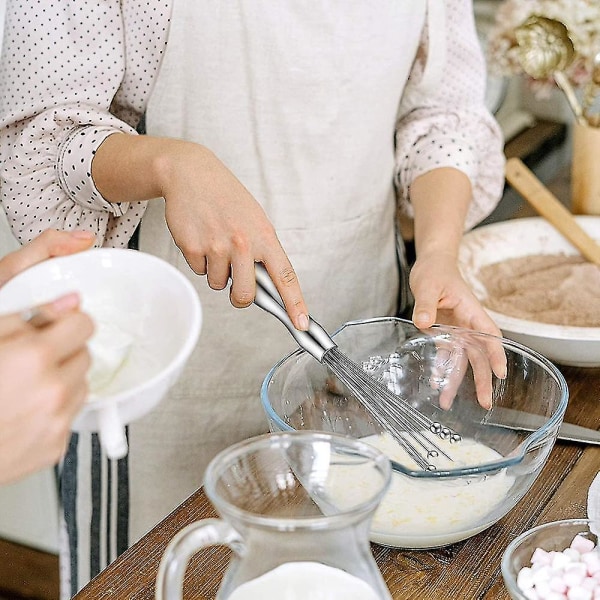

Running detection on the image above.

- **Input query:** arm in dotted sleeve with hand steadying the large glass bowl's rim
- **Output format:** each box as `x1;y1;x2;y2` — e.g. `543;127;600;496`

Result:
396;0;504;334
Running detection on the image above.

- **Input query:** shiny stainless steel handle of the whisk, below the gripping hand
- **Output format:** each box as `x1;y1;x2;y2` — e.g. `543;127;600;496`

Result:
254;263;336;362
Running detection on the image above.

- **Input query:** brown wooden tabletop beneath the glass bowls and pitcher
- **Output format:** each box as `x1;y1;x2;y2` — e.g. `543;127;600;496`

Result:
75;367;600;600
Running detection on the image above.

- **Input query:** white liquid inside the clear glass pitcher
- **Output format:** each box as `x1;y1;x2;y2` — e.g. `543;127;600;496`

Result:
227;561;381;600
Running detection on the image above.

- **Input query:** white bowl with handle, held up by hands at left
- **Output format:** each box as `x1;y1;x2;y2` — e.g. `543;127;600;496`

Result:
0;248;202;458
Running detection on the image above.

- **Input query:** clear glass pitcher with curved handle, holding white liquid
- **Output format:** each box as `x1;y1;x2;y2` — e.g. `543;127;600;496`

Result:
156;431;391;600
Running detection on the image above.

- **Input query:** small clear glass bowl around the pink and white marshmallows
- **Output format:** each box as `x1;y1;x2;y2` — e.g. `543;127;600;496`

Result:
501;519;598;600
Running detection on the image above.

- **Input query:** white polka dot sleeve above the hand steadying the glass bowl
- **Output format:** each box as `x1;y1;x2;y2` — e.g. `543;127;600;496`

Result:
396;0;504;228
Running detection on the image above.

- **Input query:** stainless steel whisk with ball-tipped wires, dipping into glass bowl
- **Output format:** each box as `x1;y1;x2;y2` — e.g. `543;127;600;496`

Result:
254;264;461;471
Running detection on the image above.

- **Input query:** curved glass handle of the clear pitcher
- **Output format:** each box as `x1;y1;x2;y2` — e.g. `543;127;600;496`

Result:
156;519;244;600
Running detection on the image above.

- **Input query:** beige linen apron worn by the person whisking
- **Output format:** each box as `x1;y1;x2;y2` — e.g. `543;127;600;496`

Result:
130;0;426;543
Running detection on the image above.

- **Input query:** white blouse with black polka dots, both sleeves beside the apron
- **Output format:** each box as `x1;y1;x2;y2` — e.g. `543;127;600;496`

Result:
0;0;503;246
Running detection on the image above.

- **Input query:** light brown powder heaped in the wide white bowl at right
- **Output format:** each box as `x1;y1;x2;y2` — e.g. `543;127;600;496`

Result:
479;254;600;327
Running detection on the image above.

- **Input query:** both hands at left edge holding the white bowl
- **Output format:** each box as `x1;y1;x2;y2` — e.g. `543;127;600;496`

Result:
0;230;95;484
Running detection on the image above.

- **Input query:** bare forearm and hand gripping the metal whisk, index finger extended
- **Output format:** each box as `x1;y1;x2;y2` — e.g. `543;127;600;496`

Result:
92;134;308;330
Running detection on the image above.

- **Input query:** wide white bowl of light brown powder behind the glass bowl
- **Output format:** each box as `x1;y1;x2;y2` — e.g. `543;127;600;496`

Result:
459;216;600;367
